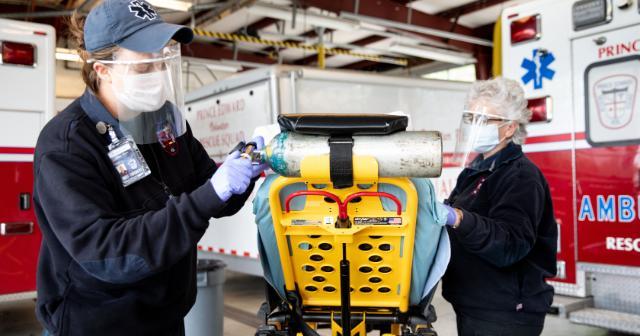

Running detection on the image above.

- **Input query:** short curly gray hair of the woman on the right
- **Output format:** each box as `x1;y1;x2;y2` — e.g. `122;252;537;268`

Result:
467;77;531;145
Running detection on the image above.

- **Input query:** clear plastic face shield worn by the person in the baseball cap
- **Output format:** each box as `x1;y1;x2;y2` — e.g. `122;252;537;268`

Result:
93;43;187;147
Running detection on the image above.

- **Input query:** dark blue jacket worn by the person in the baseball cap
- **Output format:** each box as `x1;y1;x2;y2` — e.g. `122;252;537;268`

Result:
34;94;253;336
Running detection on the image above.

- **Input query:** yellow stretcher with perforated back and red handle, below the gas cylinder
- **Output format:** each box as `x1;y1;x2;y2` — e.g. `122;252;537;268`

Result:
256;114;436;336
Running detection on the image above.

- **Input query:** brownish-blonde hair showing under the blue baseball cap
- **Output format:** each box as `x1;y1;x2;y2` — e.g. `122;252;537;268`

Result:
68;12;119;93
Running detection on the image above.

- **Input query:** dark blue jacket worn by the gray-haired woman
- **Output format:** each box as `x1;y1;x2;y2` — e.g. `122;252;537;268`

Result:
442;143;558;324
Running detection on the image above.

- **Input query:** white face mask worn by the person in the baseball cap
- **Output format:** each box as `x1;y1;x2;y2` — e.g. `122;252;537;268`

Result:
112;70;168;112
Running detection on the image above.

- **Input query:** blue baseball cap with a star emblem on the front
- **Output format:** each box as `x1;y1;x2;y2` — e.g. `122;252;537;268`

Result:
84;0;193;52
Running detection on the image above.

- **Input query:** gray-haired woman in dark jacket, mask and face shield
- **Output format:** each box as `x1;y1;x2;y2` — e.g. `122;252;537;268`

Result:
442;78;558;335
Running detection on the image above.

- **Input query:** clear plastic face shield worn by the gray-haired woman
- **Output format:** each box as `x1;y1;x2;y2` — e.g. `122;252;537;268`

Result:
453;106;512;168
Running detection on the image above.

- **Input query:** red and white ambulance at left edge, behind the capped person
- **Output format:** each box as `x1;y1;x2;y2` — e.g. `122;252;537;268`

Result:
0;19;56;303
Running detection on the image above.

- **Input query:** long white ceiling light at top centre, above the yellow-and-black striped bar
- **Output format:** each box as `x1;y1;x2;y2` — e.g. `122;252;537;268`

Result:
248;3;359;31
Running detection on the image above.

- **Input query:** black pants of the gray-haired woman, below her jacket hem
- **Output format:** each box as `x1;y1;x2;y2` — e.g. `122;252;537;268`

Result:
456;314;543;336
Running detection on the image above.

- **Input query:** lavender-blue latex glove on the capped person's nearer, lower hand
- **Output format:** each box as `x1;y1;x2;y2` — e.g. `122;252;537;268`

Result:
211;151;252;202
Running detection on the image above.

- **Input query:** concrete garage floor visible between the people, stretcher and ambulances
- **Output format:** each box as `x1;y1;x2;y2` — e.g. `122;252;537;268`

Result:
0;272;632;336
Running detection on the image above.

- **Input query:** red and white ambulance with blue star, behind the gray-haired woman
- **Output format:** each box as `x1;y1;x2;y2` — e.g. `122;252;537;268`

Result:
494;0;640;333
